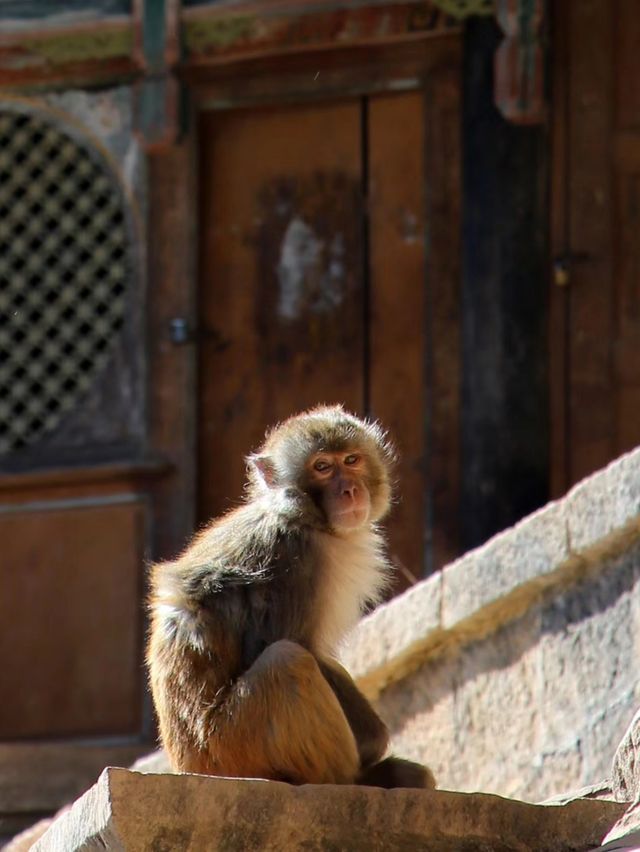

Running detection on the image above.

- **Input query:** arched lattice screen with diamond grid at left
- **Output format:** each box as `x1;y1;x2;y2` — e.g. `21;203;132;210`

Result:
0;105;130;454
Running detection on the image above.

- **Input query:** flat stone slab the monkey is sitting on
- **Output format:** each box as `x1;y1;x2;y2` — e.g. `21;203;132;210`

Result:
33;768;626;852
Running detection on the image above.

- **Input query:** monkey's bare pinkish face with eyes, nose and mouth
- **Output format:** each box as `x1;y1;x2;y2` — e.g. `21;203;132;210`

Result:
307;452;371;532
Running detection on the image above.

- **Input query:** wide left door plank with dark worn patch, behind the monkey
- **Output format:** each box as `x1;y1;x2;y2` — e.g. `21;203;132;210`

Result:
199;99;364;519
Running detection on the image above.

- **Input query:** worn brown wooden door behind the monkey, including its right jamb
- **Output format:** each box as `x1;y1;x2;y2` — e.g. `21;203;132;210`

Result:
198;78;459;585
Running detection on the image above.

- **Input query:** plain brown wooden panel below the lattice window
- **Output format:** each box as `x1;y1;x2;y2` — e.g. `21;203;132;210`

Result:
0;500;144;739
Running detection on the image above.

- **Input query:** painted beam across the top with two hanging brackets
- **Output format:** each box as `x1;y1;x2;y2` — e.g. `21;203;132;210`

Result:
0;0;546;128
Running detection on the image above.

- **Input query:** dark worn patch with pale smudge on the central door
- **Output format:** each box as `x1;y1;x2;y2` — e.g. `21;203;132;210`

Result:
256;170;363;342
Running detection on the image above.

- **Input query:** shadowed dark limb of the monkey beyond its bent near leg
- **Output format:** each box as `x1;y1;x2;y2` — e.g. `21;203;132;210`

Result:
318;659;389;769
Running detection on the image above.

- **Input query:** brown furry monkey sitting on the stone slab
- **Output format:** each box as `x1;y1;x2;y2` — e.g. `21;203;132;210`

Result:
147;405;435;787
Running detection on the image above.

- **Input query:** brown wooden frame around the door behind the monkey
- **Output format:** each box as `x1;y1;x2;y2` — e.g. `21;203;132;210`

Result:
182;29;462;587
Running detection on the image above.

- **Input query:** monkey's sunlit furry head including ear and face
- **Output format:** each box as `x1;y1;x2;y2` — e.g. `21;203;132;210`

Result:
248;405;395;532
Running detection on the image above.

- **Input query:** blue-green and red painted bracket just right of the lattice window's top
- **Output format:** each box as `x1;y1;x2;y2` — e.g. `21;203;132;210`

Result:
133;0;183;149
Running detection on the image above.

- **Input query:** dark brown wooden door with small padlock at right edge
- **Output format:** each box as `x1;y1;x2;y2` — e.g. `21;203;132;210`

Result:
551;0;640;494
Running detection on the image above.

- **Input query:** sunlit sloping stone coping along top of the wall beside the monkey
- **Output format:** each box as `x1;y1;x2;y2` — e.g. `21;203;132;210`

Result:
341;448;640;698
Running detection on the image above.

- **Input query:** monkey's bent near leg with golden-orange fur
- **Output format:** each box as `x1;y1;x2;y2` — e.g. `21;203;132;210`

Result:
211;640;360;784
